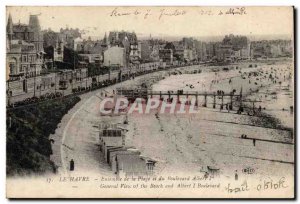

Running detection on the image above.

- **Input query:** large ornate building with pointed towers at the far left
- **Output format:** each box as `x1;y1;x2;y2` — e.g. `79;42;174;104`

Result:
6;15;44;80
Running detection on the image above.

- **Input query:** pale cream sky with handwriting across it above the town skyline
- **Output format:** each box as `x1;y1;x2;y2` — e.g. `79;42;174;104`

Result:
6;6;293;39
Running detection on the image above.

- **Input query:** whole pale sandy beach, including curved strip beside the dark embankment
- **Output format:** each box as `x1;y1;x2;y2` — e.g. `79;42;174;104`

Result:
52;59;294;181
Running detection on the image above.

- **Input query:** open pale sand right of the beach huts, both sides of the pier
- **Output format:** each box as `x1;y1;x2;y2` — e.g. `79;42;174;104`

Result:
127;60;294;176
